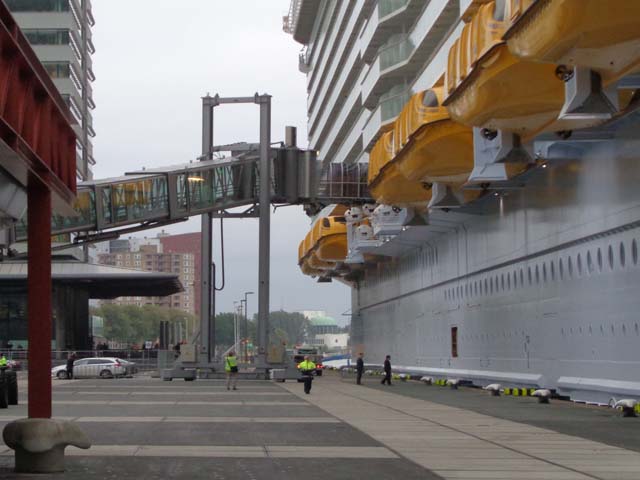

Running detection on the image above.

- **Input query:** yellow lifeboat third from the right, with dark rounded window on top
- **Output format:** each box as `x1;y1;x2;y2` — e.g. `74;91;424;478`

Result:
394;87;473;188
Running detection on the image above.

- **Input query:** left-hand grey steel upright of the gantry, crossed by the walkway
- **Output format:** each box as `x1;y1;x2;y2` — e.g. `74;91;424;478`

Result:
200;95;215;362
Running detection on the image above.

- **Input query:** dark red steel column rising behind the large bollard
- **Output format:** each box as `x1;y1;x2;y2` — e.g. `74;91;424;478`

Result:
27;177;52;418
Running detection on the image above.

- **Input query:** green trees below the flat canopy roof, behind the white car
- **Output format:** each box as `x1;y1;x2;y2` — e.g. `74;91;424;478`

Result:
92;304;196;343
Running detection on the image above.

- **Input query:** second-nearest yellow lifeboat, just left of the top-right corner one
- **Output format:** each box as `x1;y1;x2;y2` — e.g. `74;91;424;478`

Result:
444;1;564;136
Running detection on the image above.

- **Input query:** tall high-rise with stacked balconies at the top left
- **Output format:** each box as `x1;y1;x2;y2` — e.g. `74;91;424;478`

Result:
5;0;95;180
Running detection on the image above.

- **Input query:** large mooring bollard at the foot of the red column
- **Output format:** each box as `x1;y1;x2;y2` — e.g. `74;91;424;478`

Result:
2;418;91;473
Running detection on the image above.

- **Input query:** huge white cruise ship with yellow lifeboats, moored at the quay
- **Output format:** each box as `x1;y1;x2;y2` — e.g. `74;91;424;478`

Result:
284;0;640;404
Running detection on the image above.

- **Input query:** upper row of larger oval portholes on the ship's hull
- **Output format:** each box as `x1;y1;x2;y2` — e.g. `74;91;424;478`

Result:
444;239;638;301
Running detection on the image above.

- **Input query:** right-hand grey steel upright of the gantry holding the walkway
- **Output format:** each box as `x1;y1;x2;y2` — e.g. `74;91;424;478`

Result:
255;95;271;354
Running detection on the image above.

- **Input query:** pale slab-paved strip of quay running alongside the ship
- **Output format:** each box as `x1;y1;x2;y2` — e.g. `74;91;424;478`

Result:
285;376;640;479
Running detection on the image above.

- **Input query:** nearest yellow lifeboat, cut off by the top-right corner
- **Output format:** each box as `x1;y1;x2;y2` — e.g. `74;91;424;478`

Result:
505;0;640;85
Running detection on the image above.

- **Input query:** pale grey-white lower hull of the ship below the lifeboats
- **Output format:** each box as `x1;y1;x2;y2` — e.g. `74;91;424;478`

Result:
352;133;640;403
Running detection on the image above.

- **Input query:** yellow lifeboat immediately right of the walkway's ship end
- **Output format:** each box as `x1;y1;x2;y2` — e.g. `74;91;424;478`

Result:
368;131;431;207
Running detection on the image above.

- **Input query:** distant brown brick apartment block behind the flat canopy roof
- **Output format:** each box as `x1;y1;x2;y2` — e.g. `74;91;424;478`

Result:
97;239;198;314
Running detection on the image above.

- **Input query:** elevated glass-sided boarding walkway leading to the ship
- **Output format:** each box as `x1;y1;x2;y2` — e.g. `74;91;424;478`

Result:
16;149;371;241
